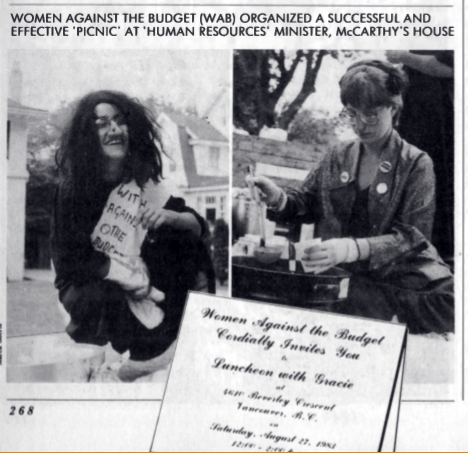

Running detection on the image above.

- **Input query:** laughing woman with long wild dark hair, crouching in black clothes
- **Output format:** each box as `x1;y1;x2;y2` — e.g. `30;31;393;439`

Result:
51;91;214;380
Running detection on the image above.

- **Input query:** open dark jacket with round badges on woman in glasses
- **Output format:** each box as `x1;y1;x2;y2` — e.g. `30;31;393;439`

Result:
268;131;452;283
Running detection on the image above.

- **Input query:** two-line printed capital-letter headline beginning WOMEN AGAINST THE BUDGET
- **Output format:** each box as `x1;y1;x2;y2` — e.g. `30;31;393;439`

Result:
10;8;455;38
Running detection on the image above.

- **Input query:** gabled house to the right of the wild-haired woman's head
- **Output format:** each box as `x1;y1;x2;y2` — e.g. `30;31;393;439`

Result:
157;108;230;224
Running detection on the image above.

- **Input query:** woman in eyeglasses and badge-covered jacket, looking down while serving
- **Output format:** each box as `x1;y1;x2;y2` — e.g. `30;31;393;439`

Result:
254;60;454;333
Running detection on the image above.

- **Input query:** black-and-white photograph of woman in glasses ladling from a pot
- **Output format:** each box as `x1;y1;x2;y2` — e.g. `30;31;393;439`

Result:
231;49;455;401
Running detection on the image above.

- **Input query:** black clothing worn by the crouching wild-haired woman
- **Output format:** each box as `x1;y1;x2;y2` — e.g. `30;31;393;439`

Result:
51;181;215;360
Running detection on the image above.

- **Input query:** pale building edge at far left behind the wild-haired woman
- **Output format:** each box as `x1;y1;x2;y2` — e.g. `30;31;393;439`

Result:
6;97;48;281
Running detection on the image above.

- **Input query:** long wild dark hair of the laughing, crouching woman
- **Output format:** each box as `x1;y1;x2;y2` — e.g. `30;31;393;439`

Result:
56;90;163;195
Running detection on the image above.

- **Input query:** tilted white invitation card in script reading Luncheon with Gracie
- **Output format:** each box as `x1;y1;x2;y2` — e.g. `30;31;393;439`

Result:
152;293;406;452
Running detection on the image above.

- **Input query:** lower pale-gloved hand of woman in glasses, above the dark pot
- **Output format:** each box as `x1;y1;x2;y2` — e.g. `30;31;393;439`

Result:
302;238;359;269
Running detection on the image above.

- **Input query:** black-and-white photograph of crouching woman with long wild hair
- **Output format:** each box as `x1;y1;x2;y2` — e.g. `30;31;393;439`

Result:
6;50;231;383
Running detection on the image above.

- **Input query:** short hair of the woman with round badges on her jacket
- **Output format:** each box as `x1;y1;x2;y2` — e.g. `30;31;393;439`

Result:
340;60;408;122
